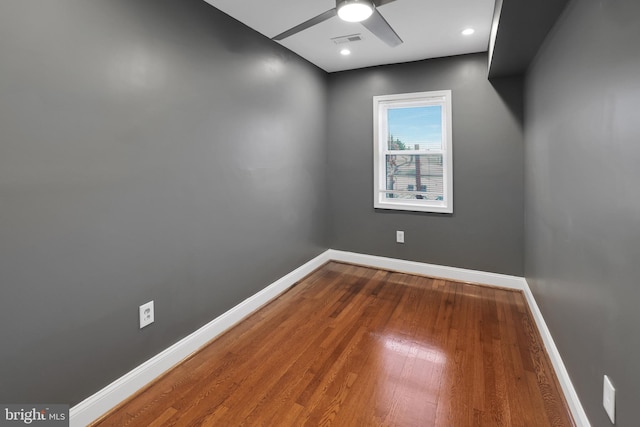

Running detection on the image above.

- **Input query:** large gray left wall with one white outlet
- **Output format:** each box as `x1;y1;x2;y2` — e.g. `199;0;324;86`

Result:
0;0;327;404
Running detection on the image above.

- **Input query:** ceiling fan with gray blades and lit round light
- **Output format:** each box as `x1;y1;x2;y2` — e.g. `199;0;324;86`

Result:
272;0;402;47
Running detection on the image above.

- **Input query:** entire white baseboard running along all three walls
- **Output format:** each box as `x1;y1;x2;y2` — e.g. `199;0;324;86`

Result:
70;249;590;427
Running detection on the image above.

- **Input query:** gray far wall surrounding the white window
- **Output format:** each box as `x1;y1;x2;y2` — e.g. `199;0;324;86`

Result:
327;54;524;275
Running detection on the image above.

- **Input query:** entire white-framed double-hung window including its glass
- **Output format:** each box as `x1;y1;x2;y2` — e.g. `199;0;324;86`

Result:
373;90;453;213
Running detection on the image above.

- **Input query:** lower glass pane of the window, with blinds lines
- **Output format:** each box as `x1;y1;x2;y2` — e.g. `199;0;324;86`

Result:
386;154;444;200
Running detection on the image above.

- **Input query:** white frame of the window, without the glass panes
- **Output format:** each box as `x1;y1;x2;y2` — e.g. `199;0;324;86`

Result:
373;90;453;213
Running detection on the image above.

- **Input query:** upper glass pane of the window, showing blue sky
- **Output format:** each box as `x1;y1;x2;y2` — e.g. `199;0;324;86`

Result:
387;105;442;150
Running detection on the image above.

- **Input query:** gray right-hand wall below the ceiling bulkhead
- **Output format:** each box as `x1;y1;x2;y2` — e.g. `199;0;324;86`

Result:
525;0;640;426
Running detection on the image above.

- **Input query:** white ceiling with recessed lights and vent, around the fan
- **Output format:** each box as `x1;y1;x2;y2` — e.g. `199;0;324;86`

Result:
205;0;495;72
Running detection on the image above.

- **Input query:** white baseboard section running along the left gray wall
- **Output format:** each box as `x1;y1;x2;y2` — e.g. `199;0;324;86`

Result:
69;251;329;427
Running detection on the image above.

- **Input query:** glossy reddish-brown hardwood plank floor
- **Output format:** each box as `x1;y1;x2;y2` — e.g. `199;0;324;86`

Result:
94;262;574;427
